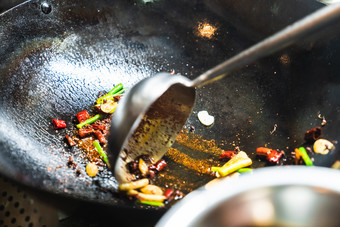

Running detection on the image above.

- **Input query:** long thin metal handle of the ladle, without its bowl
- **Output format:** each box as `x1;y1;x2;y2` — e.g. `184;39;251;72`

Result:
192;4;340;87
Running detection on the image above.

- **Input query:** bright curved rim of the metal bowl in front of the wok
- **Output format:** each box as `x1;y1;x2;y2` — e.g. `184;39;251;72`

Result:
156;166;340;227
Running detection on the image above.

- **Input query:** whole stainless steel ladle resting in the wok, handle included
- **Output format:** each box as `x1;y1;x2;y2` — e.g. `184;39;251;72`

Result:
108;4;340;183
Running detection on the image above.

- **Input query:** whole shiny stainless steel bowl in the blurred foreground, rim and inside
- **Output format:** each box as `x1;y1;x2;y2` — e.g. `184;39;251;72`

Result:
157;166;340;227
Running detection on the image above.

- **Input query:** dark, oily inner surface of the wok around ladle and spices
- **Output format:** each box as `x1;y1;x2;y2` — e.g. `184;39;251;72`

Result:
0;0;340;213
